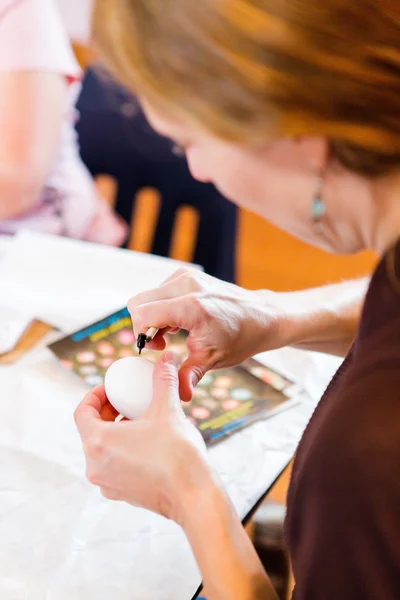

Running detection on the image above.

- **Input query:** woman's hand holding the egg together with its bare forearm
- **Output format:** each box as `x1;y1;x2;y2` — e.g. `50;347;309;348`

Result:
75;353;277;600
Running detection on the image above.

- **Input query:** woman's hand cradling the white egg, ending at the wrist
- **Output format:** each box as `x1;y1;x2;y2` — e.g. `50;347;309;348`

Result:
75;352;211;523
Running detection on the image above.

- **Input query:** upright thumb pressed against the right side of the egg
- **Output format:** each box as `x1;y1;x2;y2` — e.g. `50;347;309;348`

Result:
149;352;182;415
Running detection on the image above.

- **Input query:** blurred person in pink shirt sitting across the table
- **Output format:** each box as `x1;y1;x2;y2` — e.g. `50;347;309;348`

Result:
0;0;126;246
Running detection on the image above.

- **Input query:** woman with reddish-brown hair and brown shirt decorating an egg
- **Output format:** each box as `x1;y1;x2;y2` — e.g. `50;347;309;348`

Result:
76;0;400;600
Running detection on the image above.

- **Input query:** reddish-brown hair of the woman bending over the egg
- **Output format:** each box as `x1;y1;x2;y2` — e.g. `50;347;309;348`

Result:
94;0;400;176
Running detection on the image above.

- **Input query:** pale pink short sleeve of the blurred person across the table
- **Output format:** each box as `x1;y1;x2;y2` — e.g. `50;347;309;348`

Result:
0;0;81;79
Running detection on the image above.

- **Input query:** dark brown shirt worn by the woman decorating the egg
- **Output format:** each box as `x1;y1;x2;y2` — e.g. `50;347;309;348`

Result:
286;244;400;600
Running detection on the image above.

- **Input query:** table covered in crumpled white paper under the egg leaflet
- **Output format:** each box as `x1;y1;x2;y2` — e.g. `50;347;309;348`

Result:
0;236;336;600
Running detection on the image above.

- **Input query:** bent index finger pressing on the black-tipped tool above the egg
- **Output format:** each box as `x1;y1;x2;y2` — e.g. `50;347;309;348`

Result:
131;294;201;337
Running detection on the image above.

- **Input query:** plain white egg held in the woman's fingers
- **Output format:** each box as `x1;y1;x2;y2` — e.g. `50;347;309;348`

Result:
104;356;155;419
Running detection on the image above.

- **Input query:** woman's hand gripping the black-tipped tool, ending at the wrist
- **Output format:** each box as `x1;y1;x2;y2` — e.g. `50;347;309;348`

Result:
128;268;287;401
